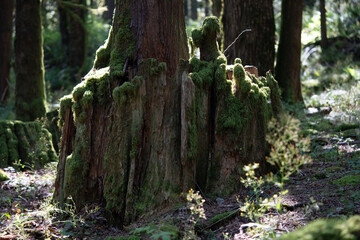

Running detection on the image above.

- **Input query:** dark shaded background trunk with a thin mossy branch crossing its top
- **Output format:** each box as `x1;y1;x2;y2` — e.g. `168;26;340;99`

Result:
58;0;87;83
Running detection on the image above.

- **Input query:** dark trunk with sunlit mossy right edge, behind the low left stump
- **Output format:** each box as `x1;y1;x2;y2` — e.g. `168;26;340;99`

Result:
15;0;46;121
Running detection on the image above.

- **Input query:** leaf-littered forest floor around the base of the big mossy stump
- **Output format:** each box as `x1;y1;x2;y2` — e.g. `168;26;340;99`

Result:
0;107;360;240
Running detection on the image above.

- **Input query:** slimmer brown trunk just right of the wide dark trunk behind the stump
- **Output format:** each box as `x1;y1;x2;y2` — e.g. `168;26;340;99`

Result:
275;0;303;103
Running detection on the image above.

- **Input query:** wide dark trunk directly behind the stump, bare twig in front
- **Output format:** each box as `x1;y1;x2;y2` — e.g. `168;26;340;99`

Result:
222;0;275;76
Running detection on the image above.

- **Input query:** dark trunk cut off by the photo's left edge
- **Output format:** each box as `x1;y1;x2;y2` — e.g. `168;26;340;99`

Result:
0;0;14;104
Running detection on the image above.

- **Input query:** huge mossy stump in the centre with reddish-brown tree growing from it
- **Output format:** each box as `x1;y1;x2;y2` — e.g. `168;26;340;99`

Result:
54;0;277;226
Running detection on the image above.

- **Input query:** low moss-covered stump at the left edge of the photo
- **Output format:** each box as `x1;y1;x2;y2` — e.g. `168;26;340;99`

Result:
0;120;57;168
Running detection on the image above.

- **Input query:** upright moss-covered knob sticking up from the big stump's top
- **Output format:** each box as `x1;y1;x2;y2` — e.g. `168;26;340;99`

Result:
191;17;221;61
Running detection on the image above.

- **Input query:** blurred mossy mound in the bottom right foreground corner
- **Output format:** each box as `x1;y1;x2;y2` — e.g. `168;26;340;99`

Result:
278;216;360;240
